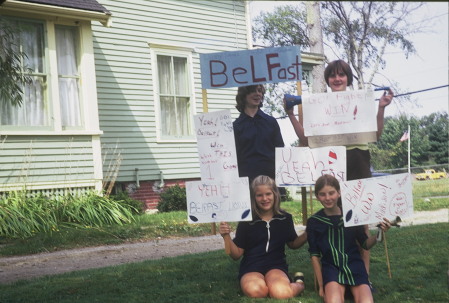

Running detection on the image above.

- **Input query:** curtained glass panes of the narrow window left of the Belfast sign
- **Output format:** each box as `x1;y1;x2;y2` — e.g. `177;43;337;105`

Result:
157;54;192;139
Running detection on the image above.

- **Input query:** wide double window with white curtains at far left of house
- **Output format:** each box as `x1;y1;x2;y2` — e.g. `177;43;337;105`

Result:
0;20;82;130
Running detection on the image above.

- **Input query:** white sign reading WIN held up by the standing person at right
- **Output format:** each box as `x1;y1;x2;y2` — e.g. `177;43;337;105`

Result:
302;90;377;137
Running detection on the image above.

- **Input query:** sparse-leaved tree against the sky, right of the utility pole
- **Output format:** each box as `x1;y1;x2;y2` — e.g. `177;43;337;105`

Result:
322;1;424;88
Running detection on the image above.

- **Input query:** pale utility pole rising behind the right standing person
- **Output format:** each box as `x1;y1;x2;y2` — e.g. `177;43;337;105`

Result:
306;1;327;93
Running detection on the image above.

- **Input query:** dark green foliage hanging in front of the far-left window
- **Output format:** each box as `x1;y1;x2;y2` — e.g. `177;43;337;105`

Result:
0;17;32;105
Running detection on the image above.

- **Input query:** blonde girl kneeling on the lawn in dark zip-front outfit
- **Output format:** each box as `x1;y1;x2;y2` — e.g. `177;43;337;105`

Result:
219;175;307;299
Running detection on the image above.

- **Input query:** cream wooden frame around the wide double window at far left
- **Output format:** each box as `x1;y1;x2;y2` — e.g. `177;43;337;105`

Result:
0;15;102;136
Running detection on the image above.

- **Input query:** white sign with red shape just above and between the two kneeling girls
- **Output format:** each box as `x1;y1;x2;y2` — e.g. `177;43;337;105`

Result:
276;146;346;186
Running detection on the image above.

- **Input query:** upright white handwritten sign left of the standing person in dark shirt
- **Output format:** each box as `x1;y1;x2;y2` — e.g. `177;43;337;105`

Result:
194;110;239;181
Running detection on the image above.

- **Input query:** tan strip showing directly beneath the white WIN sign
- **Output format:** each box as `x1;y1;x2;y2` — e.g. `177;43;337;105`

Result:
308;132;377;148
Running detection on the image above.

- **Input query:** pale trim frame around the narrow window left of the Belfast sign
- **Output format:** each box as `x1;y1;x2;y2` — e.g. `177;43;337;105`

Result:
150;43;196;143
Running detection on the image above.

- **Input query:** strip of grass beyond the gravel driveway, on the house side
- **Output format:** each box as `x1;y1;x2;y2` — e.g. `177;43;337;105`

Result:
0;179;449;256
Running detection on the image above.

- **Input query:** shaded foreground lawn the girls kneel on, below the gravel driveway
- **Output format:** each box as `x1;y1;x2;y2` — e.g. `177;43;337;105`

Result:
0;223;449;303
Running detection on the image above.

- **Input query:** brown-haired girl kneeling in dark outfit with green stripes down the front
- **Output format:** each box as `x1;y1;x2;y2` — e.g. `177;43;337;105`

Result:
306;175;390;303
